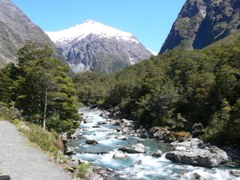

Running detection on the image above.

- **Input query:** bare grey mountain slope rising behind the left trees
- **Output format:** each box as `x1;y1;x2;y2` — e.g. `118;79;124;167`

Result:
0;0;64;67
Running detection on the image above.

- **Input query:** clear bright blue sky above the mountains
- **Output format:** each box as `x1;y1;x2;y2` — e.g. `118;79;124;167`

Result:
12;0;185;52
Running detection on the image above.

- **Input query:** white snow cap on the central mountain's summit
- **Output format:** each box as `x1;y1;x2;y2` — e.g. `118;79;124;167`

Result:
46;20;139;44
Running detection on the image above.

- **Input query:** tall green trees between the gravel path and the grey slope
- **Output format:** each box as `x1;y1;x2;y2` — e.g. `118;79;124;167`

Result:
0;42;80;132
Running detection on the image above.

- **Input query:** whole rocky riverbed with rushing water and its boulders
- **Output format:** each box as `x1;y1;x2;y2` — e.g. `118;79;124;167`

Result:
65;108;240;180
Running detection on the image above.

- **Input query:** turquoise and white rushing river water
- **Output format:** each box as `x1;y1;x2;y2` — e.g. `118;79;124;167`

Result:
69;108;240;180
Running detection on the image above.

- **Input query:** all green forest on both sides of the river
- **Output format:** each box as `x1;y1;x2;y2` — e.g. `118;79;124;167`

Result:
0;34;240;147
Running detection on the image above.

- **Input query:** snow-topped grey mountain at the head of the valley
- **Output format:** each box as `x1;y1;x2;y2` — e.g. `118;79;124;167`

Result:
46;20;152;73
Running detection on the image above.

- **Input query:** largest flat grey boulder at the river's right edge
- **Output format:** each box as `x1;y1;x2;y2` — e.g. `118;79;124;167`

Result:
166;140;229;168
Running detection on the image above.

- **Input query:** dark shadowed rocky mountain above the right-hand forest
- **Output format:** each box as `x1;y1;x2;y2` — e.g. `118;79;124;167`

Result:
160;0;240;53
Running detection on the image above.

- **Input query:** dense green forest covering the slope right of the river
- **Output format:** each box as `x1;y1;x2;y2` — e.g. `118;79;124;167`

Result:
74;32;240;146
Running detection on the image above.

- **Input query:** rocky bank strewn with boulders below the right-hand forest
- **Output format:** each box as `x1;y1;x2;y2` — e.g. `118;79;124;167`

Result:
100;107;240;167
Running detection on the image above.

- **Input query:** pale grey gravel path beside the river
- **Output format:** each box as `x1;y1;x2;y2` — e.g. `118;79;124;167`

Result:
0;121;72;180
